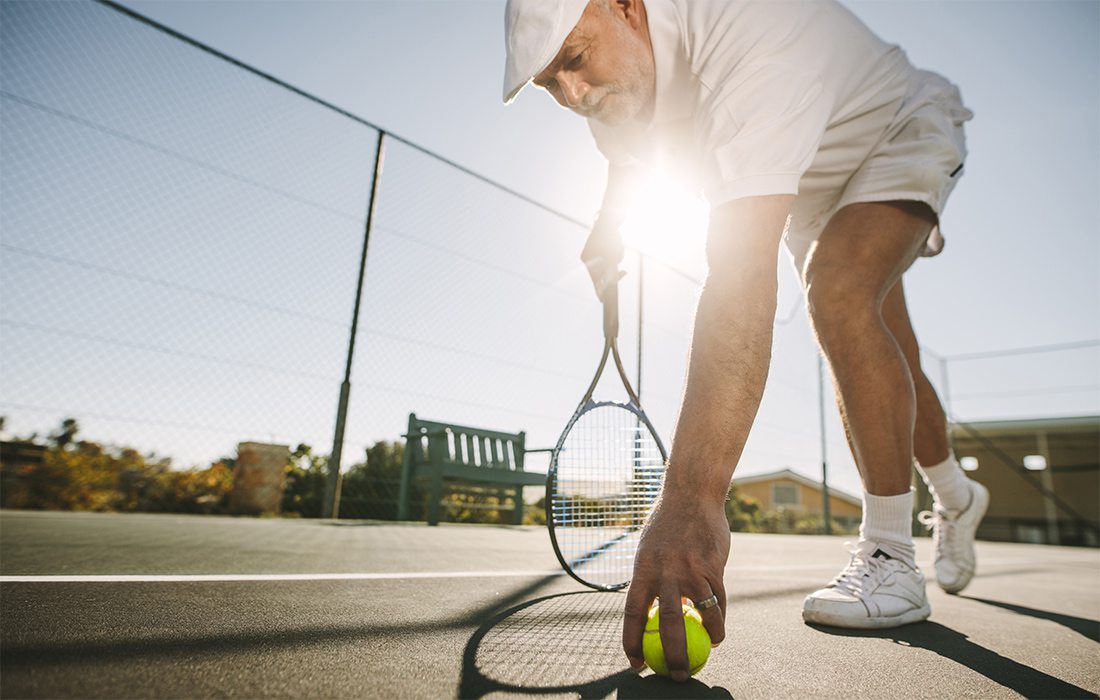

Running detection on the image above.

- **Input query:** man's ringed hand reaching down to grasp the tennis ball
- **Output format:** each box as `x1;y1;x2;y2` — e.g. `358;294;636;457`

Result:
623;496;729;680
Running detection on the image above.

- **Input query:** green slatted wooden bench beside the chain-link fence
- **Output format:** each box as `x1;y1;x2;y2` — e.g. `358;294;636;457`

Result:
397;413;548;525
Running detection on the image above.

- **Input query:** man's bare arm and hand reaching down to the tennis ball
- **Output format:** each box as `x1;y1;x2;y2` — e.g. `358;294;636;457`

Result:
623;196;793;680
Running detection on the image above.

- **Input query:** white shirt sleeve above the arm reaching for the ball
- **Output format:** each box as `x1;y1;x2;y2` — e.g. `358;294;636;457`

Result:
699;63;832;206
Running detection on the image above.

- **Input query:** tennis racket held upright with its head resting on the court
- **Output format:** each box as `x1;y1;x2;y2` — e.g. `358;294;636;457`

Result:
546;271;668;591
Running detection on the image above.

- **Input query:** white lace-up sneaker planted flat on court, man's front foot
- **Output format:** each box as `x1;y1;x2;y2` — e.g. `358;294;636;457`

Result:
802;542;932;630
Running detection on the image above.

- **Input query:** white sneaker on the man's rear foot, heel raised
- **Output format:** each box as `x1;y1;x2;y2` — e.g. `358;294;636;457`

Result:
916;481;989;593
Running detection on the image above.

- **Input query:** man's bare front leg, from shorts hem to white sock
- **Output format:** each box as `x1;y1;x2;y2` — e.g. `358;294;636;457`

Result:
803;203;938;496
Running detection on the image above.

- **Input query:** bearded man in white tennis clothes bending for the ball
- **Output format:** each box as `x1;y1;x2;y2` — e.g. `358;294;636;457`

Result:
504;0;989;680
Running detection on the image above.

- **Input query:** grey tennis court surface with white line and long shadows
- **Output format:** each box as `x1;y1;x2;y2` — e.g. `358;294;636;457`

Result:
0;511;1100;698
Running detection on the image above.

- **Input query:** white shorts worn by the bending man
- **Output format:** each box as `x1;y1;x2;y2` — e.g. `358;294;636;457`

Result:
785;70;974;274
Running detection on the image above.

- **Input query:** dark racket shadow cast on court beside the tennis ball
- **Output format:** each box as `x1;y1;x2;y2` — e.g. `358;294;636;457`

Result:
457;591;733;698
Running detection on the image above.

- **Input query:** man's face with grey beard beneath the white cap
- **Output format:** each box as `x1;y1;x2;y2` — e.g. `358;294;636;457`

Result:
534;0;656;127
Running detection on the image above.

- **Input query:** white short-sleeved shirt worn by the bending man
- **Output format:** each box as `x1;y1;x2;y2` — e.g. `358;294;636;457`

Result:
589;0;913;206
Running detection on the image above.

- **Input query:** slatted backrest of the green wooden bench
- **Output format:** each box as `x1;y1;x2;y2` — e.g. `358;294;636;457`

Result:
405;413;526;471
